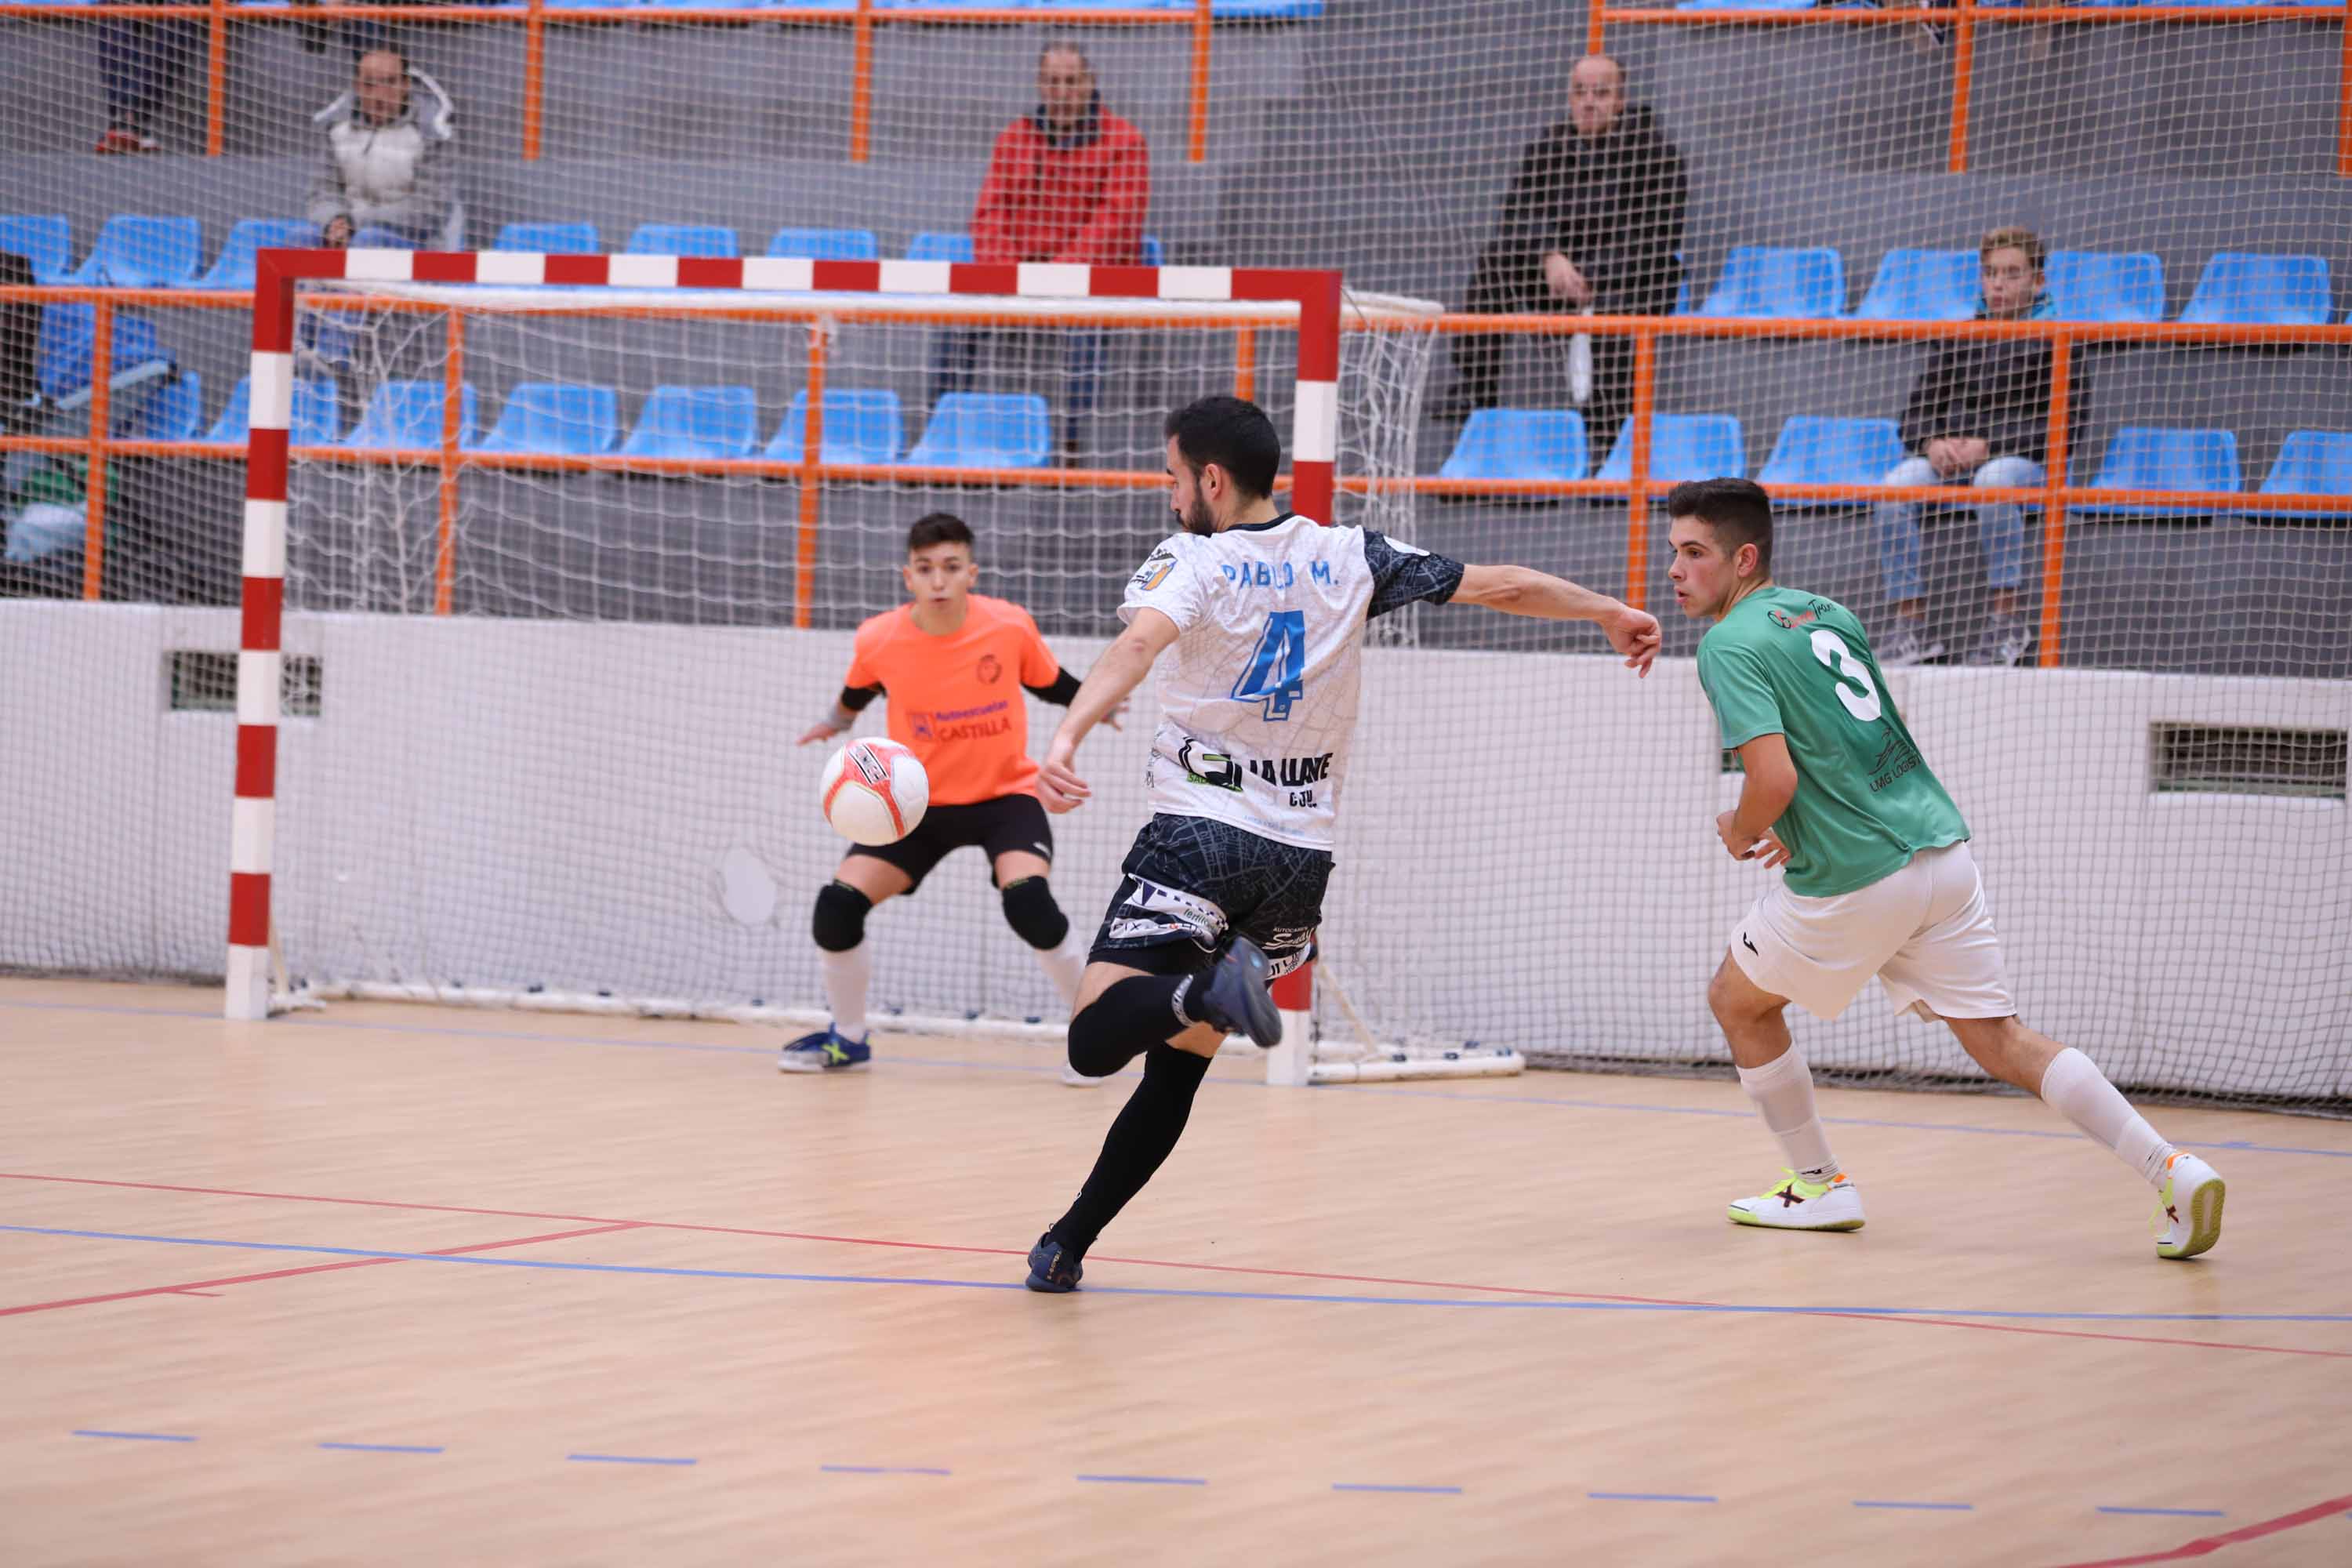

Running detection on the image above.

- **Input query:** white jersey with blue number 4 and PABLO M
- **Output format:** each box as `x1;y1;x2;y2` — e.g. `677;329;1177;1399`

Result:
1120;513;1463;848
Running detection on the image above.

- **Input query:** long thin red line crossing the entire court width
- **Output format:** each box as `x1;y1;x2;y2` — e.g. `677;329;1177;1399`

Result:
0;1171;2352;1361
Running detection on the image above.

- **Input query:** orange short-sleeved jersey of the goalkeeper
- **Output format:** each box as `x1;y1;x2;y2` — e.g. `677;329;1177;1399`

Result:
842;595;1061;806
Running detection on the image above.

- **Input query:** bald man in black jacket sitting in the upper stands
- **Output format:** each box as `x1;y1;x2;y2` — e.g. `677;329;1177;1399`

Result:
1439;54;1689;459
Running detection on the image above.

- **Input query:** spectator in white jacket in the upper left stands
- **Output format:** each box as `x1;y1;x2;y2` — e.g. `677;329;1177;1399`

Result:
310;45;466;249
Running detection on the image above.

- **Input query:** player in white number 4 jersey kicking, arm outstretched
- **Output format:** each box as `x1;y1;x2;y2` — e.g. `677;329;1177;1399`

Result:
1028;397;1658;1293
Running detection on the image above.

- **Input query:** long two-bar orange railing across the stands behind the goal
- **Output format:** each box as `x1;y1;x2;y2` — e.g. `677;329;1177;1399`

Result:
0;287;2352;666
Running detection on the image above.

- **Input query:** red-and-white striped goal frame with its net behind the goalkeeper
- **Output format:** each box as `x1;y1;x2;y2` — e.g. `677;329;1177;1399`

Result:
230;252;1468;1081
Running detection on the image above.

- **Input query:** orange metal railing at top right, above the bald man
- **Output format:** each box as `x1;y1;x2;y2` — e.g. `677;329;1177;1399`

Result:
1585;0;2352;179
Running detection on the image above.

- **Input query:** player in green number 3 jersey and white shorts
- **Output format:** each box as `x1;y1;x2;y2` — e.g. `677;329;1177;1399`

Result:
1665;480;2223;1258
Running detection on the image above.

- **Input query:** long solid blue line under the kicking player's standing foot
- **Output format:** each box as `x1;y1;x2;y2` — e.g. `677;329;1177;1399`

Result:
0;1225;2352;1323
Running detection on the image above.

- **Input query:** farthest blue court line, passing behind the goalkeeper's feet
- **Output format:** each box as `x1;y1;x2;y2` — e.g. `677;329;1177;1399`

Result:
0;999;2352;1159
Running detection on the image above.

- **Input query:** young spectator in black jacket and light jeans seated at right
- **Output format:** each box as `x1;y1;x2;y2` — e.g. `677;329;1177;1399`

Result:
1872;228;2082;666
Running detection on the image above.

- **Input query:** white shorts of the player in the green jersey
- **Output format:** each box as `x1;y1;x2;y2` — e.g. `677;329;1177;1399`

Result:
1731;844;2018;1018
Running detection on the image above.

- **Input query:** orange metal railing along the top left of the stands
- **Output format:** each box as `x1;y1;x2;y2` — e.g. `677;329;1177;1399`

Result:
0;0;1216;162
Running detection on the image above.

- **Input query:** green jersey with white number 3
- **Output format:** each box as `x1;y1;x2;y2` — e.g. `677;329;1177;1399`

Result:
1698;588;1969;898
